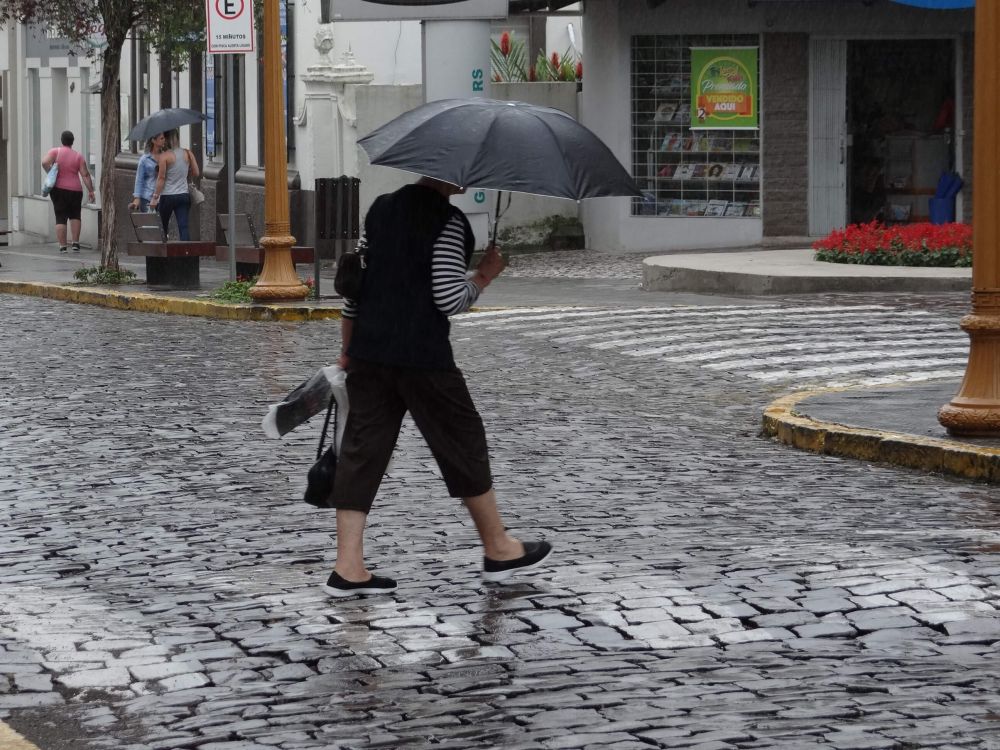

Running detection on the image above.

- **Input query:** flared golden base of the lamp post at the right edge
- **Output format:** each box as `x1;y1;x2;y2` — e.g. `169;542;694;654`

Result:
938;311;1000;437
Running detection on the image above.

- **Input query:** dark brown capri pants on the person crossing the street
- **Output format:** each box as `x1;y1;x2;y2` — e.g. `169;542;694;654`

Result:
329;359;493;513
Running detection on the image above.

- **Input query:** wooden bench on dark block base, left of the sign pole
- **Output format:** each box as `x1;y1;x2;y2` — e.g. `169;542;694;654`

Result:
128;213;215;289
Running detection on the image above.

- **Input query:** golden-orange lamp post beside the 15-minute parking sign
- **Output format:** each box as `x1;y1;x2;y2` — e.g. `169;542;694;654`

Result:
250;0;309;302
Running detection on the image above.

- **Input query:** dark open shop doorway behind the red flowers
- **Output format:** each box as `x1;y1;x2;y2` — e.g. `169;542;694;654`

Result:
847;39;955;223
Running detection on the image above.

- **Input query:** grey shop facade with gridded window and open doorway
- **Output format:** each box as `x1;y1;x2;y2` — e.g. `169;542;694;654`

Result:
582;0;975;252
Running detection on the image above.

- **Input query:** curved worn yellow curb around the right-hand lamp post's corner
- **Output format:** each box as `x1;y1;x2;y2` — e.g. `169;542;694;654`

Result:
762;388;1000;484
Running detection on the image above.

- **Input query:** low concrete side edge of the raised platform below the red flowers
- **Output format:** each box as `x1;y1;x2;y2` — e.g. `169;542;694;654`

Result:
642;262;971;296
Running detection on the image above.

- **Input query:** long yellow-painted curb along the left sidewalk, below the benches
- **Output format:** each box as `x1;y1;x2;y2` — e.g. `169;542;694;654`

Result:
0;281;340;322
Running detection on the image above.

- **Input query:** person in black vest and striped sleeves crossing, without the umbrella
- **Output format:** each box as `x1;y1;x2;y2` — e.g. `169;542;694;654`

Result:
324;177;552;597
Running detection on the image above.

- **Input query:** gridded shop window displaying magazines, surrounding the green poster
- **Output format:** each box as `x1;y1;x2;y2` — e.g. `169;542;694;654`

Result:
632;34;761;218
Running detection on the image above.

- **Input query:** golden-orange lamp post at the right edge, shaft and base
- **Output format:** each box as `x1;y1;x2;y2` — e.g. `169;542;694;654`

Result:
938;0;1000;437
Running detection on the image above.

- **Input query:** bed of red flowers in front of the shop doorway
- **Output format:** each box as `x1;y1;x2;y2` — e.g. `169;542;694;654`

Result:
813;221;972;266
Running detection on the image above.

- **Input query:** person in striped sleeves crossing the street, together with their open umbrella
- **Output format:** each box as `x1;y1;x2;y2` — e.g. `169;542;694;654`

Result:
316;98;642;596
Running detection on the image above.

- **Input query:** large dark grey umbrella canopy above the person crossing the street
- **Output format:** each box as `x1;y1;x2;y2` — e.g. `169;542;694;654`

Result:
359;99;642;200
